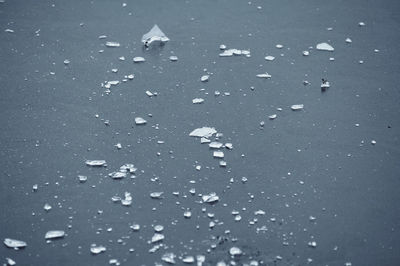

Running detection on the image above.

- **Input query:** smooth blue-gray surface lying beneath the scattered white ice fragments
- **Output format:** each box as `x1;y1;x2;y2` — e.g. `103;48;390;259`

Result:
0;0;400;265
